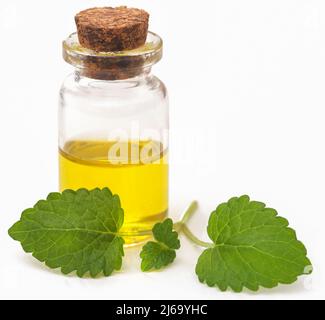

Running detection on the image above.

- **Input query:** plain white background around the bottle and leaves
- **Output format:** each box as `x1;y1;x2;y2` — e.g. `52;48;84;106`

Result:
0;0;325;299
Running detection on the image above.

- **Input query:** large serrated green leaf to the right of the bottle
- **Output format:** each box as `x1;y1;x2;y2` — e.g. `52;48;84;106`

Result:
196;196;312;292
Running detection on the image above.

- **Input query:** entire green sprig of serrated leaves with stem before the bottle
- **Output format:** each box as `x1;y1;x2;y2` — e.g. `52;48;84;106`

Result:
9;188;312;292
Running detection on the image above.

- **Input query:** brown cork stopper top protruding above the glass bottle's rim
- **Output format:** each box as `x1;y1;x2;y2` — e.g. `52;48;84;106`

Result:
75;6;149;52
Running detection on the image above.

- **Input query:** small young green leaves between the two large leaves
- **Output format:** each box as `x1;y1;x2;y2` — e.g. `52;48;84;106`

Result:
140;219;181;272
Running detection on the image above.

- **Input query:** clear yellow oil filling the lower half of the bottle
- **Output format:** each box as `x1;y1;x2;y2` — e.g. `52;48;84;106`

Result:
59;140;168;244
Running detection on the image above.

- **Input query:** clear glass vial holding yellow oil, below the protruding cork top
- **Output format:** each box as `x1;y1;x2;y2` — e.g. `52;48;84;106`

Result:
59;32;169;244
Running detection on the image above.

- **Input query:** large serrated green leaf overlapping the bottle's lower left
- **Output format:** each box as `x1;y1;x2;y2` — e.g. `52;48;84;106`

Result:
9;188;124;277
